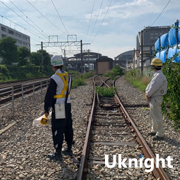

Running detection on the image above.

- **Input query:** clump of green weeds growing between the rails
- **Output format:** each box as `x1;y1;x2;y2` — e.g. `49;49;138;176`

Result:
95;86;117;97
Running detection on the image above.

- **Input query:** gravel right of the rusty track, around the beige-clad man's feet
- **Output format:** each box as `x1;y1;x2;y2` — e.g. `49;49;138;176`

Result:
116;76;180;180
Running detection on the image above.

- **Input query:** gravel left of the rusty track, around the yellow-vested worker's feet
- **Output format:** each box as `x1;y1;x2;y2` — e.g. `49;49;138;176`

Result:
0;82;93;180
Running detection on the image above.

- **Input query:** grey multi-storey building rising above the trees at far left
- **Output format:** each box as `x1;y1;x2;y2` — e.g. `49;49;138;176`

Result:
0;24;30;50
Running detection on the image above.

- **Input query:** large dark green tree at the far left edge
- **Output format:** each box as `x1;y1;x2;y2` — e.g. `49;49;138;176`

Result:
0;37;18;65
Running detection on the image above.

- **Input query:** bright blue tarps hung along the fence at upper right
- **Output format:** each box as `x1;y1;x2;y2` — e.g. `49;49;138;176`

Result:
155;21;180;63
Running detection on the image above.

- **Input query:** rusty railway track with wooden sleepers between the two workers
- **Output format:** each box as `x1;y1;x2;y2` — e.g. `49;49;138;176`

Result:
77;77;169;180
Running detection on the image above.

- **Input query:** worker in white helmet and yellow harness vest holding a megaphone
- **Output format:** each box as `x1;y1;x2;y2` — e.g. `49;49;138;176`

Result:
44;55;73;161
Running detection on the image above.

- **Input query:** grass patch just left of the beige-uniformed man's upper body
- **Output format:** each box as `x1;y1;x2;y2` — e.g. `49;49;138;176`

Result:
125;69;151;92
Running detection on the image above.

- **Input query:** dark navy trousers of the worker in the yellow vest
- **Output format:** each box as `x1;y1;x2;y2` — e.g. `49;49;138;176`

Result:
52;103;73;151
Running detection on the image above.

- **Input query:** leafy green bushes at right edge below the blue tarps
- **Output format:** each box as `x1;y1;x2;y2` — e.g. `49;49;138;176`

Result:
162;54;180;130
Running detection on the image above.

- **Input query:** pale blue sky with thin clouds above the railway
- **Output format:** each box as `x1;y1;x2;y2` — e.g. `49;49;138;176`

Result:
0;0;180;59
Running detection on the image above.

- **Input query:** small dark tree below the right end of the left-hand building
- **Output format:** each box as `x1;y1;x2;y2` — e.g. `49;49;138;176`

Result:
18;46;30;66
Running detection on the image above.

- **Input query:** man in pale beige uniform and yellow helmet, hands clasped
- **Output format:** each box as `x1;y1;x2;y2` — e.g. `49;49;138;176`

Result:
146;58;167;140
